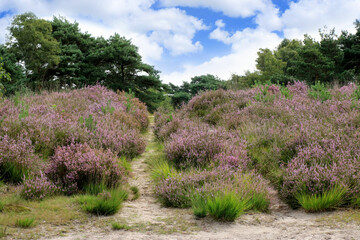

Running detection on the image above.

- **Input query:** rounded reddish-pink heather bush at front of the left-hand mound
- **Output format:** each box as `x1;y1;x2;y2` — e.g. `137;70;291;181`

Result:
45;143;124;194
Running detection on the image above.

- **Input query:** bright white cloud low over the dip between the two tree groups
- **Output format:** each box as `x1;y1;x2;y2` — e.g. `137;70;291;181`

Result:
161;25;281;85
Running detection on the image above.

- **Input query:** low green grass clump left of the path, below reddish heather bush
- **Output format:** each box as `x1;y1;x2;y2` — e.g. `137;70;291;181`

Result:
79;189;128;216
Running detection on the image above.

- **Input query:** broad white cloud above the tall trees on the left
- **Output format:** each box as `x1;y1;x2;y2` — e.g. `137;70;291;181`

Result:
0;0;207;62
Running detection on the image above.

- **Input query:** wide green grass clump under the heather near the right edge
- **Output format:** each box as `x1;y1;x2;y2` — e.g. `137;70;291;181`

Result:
296;186;347;212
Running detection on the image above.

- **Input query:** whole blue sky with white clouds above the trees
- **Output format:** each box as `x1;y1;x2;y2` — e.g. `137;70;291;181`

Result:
0;0;360;84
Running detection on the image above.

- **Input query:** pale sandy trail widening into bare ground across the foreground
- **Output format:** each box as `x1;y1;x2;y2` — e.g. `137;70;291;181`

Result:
47;124;360;240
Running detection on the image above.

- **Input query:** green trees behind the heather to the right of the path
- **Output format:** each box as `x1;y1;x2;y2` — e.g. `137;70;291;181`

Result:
227;20;360;89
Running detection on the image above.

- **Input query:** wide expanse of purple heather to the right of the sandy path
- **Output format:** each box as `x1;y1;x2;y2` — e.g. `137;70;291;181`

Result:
154;81;360;212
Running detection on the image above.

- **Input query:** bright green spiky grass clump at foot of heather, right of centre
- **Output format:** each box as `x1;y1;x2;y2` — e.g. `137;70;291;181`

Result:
207;192;249;221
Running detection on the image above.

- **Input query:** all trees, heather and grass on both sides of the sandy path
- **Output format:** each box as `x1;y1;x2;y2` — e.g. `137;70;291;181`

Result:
0;10;360;238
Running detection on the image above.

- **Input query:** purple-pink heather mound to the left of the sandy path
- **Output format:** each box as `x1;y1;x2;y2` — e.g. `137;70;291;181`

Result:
0;85;149;199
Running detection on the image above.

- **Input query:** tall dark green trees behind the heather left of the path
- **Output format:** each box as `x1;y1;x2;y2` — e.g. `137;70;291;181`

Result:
0;12;164;111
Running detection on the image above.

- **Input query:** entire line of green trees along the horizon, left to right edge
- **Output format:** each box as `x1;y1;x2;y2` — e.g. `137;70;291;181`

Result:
0;12;360;109
